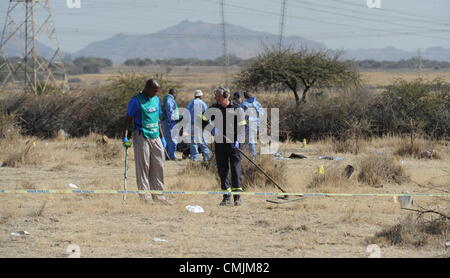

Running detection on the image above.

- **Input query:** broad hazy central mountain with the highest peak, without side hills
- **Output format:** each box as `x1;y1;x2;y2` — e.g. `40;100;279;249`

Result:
73;21;326;63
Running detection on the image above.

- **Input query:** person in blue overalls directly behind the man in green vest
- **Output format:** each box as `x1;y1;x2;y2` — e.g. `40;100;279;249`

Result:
161;89;180;160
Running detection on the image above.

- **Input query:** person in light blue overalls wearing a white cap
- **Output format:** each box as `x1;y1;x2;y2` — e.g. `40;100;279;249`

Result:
186;90;211;161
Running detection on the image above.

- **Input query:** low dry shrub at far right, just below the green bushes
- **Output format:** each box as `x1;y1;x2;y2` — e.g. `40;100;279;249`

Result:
394;139;441;159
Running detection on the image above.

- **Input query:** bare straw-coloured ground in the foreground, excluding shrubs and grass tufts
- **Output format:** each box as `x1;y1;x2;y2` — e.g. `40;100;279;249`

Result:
0;138;450;258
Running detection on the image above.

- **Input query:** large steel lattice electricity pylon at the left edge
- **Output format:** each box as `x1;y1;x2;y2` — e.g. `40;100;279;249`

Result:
0;0;67;94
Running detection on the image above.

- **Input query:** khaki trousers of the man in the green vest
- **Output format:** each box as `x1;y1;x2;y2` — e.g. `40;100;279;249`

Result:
133;131;165;200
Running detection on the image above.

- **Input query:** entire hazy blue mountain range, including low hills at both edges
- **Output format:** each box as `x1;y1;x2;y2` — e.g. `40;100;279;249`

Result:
2;20;450;64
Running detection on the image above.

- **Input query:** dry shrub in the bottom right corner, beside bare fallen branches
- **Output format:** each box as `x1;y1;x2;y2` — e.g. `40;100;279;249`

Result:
369;215;450;247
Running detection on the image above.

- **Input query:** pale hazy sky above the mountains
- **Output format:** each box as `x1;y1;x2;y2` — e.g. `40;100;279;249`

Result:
0;0;450;52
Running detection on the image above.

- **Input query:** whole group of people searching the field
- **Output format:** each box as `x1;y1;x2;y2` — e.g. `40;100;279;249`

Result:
123;79;263;206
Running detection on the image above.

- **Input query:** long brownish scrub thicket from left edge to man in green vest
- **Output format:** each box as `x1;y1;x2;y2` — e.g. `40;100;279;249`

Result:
0;74;176;138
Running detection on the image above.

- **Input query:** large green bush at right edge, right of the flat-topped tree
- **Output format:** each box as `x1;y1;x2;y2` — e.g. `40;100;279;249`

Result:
370;78;450;137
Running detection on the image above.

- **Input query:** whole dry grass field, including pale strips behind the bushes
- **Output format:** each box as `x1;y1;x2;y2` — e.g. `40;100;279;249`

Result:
0;67;450;258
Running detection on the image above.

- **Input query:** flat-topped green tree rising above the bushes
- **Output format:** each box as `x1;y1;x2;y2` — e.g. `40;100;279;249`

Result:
235;48;360;104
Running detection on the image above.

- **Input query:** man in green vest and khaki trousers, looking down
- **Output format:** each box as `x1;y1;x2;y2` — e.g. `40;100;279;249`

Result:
123;79;172;205
